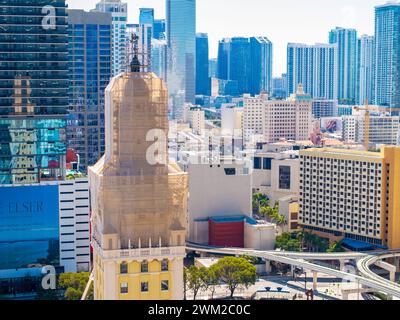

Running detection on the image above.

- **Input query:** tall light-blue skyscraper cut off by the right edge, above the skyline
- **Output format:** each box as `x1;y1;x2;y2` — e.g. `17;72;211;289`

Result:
375;3;400;108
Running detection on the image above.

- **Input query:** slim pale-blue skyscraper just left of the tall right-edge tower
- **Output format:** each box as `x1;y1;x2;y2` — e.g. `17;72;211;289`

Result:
357;35;375;105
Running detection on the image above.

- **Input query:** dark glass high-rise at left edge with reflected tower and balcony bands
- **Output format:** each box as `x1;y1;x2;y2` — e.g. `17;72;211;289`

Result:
0;0;68;184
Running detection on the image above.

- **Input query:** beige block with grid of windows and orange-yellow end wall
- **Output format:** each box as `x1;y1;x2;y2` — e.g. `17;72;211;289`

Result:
299;147;400;249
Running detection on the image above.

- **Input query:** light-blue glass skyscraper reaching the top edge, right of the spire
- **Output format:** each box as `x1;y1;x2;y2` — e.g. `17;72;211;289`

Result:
166;0;196;108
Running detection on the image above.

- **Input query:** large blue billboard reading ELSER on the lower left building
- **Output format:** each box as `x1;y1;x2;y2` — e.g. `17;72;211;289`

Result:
0;185;60;270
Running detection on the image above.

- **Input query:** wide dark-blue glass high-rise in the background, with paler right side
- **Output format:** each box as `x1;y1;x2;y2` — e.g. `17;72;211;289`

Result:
217;37;272;95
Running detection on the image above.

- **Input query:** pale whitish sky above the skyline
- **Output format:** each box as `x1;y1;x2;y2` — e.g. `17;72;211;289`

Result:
67;0;387;75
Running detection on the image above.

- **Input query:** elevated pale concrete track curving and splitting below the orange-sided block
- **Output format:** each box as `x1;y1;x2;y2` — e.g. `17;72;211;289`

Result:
187;244;400;298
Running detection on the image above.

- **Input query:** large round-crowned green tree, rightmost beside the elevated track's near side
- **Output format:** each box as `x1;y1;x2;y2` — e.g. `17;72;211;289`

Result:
215;257;257;298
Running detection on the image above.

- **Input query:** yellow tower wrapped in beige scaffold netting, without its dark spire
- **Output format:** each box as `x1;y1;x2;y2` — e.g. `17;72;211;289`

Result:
89;72;188;300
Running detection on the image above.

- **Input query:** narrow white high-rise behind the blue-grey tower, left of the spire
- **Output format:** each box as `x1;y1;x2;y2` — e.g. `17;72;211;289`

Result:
96;0;128;76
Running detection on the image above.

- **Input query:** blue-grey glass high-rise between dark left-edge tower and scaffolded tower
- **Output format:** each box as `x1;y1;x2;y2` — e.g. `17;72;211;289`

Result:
67;10;112;171
